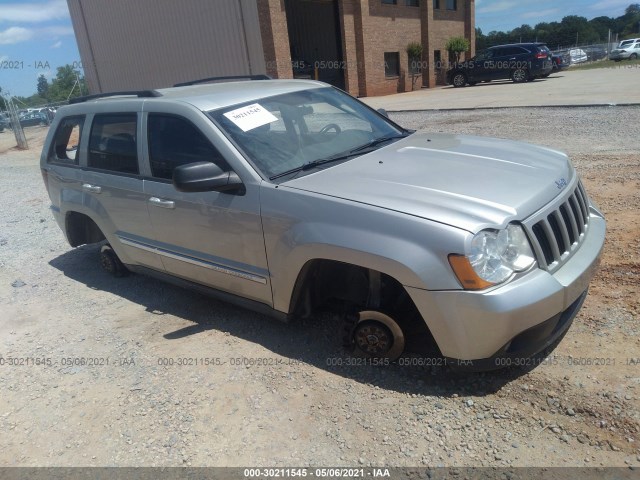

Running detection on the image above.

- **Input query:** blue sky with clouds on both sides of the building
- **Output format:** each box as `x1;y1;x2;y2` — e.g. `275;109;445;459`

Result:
0;0;636;96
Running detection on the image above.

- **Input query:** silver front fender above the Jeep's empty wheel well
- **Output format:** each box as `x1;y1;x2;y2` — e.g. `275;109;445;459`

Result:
261;185;468;312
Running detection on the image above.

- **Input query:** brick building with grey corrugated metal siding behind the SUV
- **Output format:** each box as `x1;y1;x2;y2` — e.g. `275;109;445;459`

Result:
67;0;475;96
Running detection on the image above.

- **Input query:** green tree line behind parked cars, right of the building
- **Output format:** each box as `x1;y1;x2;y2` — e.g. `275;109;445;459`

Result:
476;3;640;50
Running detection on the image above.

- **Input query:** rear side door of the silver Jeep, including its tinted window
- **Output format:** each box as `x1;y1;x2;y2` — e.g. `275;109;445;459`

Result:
82;112;162;270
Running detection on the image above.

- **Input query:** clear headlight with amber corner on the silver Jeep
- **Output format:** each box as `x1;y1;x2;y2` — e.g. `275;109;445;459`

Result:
449;224;536;290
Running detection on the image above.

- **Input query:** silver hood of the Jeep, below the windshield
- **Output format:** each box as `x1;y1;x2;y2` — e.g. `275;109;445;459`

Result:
281;134;574;233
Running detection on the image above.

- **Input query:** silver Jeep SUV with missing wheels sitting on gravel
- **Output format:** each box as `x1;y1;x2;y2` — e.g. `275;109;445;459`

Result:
41;80;605;370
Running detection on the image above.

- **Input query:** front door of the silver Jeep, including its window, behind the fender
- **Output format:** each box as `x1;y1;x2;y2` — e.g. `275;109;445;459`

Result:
145;110;273;305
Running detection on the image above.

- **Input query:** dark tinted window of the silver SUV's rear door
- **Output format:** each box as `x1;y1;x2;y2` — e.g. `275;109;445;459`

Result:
88;113;140;175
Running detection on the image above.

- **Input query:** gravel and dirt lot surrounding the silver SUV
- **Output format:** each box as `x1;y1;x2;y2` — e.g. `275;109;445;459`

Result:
0;107;640;467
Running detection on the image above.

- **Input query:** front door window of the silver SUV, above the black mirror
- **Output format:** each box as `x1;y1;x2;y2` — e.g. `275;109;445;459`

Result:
147;113;230;180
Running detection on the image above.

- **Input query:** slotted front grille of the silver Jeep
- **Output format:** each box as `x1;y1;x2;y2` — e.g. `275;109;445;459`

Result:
531;183;589;267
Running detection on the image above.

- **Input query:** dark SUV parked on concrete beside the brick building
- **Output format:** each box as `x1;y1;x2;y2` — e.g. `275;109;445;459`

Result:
447;43;553;87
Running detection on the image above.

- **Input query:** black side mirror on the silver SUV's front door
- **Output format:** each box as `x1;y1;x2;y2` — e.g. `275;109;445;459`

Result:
173;162;245;195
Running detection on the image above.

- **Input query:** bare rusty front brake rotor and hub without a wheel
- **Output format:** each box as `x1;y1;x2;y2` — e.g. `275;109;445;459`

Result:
351;310;405;361
